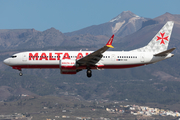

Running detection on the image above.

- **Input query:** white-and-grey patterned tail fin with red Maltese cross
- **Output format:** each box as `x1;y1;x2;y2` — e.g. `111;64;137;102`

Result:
132;21;174;53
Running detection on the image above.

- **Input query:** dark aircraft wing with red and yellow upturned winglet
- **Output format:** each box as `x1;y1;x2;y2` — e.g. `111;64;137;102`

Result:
77;35;114;66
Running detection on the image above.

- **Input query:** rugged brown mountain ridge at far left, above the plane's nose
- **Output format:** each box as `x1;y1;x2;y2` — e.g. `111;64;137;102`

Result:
0;28;66;50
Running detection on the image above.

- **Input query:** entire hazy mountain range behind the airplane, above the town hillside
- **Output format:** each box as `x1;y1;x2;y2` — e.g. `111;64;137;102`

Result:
0;11;180;102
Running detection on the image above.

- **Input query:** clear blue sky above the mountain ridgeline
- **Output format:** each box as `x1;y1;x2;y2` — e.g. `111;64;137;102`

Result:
0;0;180;33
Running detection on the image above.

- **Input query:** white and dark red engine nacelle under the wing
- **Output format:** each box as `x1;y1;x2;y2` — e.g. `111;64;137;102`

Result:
59;59;77;74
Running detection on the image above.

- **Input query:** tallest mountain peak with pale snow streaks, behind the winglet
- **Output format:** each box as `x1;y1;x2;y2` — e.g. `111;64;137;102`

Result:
65;11;148;37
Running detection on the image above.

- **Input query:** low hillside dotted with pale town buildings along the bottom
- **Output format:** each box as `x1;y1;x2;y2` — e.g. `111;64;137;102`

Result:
0;96;177;120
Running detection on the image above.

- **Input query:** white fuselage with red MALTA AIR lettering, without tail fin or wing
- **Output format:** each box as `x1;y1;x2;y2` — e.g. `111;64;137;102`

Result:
4;51;173;70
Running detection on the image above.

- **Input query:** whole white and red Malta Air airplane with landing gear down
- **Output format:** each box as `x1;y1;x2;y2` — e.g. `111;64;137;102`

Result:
3;21;175;77
